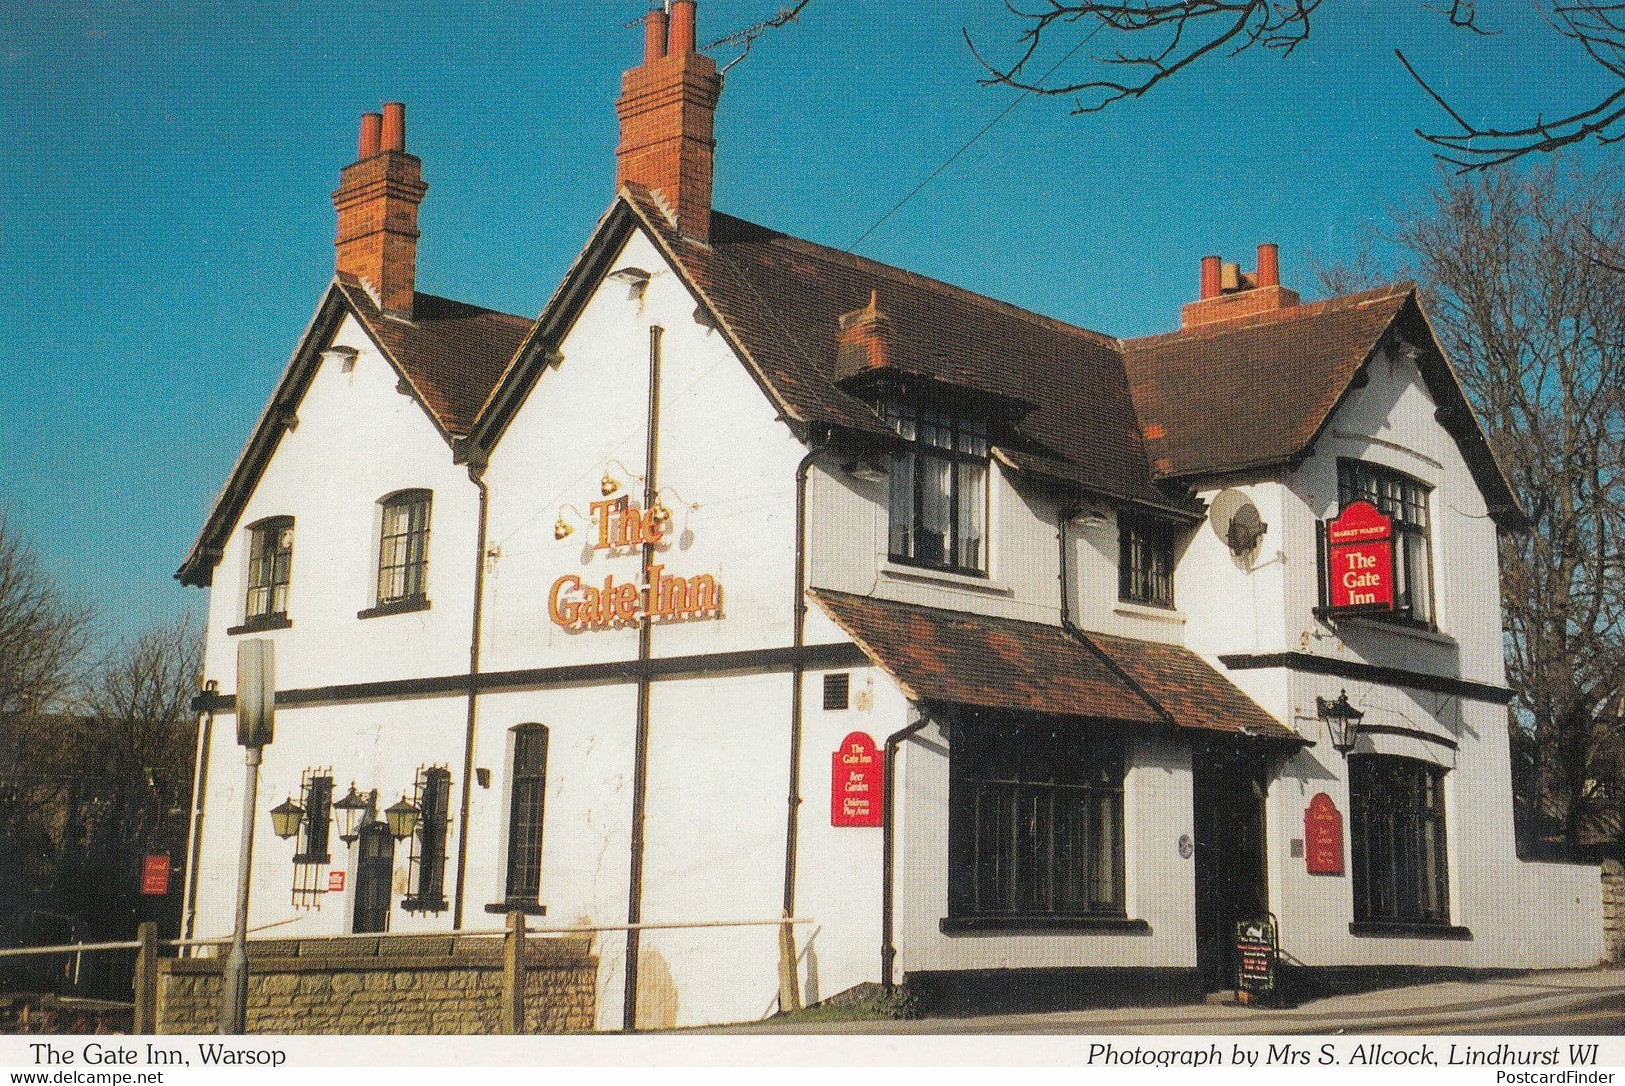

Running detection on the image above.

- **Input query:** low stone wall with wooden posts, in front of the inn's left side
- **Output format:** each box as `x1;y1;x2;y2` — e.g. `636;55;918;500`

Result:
158;935;598;1034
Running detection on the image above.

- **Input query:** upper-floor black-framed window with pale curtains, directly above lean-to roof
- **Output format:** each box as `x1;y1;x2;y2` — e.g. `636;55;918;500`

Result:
882;402;988;574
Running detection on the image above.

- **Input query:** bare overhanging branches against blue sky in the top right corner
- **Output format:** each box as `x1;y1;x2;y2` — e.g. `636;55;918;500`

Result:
965;0;1625;171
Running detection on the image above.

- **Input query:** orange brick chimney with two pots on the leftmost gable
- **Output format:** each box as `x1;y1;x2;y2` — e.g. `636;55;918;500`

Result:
333;102;429;320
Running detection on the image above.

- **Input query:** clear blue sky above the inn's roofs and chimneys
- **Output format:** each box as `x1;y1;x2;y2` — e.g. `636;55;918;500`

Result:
0;0;1601;650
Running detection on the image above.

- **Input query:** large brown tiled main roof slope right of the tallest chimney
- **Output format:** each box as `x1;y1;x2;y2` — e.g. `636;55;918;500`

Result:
626;187;1170;504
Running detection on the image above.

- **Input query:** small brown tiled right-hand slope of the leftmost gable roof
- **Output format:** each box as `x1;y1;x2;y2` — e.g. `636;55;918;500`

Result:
336;275;535;436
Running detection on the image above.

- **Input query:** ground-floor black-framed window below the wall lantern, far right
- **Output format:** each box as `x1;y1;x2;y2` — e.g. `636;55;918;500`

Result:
1349;754;1450;925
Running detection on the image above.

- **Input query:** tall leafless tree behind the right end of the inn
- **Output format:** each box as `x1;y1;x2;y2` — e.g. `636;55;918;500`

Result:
1321;164;1625;845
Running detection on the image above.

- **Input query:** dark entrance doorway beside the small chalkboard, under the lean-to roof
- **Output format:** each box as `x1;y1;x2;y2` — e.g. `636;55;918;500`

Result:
1191;740;1269;992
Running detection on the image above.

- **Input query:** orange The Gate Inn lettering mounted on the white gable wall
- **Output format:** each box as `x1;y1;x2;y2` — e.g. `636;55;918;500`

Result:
548;494;722;629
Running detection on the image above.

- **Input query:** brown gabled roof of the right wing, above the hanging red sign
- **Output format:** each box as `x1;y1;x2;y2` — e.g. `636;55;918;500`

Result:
1123;283;1523;527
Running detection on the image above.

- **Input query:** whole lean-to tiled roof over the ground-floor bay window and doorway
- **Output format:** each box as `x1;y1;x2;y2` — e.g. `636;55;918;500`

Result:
809;589;1295;740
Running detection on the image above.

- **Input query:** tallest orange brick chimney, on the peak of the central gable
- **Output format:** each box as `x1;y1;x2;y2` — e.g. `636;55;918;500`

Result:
614;0;722;241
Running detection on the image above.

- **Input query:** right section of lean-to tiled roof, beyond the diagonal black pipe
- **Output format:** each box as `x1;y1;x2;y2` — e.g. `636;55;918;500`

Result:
1086;631;1298;740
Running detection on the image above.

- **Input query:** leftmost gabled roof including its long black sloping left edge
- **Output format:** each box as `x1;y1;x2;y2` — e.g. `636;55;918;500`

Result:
176;275;531;587
